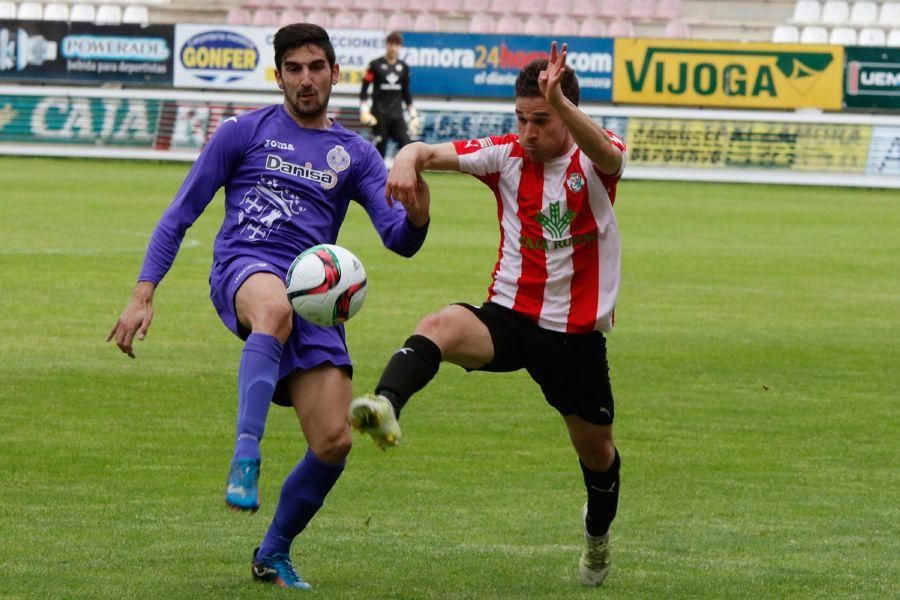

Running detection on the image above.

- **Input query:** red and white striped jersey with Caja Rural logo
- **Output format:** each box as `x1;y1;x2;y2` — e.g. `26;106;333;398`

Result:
454;131;625;333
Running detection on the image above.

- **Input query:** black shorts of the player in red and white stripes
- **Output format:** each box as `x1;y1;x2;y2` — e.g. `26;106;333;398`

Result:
459;302;614;425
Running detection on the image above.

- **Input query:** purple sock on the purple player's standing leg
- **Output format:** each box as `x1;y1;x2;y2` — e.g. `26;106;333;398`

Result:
257;449;344;557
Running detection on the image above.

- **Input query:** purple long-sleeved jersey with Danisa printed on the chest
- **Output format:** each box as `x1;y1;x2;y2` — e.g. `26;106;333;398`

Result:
138;104;427;284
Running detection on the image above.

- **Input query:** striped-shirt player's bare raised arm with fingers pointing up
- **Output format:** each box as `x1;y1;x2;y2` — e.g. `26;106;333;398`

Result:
538;42;622;175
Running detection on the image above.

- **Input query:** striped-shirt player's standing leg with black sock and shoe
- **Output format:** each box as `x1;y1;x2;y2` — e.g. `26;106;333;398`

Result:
565;415;620;586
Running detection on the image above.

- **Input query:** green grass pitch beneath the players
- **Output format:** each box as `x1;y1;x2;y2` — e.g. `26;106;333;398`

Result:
0;158;900;599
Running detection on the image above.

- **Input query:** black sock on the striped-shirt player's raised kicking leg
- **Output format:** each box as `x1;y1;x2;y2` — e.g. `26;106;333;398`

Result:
375;335;441;418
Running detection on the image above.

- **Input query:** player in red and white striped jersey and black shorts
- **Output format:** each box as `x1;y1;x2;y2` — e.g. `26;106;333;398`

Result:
350;42;625;585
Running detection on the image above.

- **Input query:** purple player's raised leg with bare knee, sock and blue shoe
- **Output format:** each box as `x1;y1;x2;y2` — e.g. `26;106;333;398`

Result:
225;272;293;512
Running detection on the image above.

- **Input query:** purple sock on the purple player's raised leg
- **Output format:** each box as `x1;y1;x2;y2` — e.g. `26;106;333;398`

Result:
233;333;283;460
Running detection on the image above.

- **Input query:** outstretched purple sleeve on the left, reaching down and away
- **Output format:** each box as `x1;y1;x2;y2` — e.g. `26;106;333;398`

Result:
138;121;244;284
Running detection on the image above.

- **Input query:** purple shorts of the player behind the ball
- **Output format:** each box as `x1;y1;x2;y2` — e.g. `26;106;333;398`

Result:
209;257;353;406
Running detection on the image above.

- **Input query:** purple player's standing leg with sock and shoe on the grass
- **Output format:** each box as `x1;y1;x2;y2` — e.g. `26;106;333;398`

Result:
253;364;352;589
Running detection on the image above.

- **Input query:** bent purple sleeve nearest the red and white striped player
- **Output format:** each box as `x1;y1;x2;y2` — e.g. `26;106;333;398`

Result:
356;143;428;257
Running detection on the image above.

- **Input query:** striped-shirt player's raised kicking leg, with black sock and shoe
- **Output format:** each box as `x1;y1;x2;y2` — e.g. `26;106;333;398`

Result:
350;305;494;448
